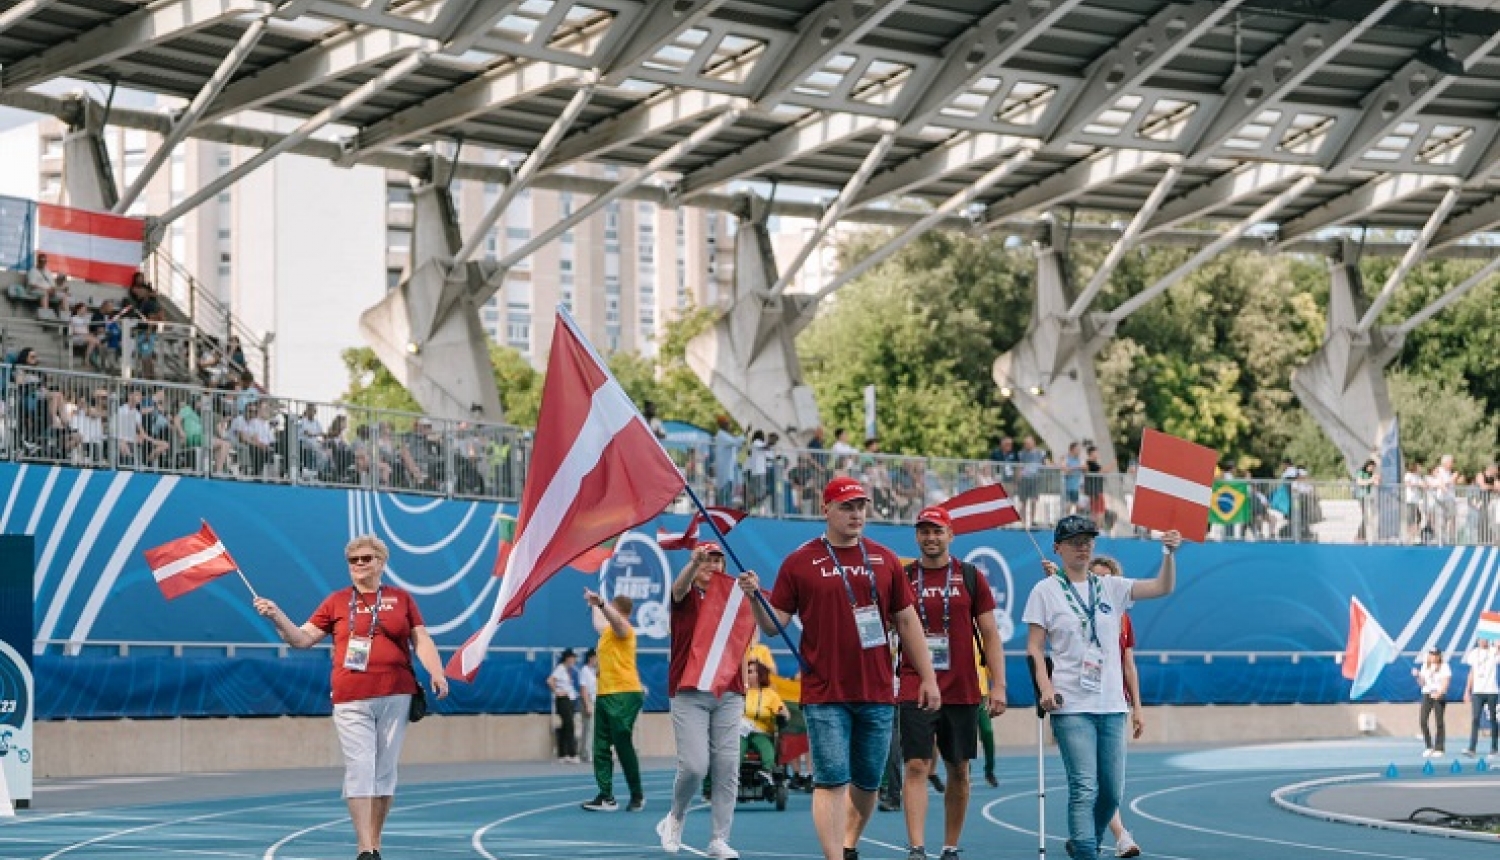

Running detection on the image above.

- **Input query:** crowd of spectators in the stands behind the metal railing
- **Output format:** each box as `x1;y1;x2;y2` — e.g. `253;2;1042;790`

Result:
0;268;1500;545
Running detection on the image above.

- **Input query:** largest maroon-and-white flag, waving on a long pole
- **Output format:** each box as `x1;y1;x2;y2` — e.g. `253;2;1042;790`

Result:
447;308;686;681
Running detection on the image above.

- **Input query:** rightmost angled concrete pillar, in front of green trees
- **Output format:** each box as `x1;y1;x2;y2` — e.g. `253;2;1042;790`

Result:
1292;245;1404;474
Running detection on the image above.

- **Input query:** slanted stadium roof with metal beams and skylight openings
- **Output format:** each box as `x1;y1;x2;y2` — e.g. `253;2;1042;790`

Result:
0;0;1500;251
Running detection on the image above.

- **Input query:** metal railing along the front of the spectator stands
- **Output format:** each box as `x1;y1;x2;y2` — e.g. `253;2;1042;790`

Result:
0;360;1500;545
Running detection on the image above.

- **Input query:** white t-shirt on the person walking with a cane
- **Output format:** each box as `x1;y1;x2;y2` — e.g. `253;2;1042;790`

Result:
1022;576;1136;714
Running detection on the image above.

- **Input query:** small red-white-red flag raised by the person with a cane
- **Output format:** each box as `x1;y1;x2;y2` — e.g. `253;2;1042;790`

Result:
1130;429;1218;543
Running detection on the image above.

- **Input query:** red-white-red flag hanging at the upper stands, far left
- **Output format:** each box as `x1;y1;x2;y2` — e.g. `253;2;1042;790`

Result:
36;203;146;287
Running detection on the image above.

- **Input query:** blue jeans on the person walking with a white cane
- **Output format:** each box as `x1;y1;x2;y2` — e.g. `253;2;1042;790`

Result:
1052;713;1127;860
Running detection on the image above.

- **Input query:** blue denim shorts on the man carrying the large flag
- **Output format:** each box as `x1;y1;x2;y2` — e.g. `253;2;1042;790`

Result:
803;702;896;791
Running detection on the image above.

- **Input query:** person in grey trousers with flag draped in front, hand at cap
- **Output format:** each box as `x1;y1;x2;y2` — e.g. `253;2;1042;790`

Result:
657;542;753;860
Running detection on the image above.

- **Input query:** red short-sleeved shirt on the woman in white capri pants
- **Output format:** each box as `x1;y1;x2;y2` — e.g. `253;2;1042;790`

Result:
308;585;425;704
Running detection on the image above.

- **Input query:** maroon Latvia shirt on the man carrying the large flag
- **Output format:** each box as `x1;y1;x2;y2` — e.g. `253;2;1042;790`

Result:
771;537;912;704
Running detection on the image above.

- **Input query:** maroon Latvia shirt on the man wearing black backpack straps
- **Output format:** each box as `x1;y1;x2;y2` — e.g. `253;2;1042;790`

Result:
900;561;995;705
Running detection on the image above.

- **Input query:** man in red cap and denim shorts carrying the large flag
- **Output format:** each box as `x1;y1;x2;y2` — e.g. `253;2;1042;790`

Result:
740;477;942;860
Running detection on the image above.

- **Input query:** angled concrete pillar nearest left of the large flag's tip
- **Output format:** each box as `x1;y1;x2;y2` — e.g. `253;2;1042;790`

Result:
360;165;504;422
